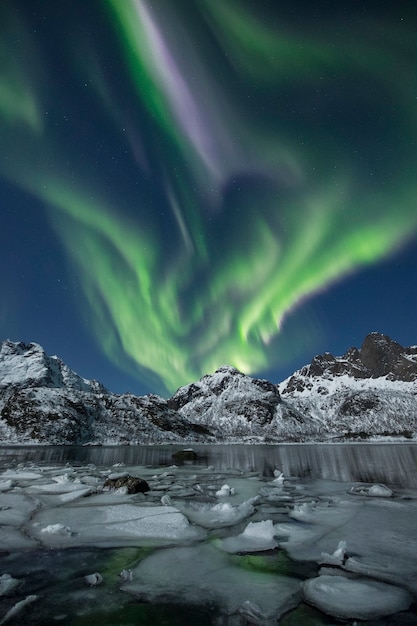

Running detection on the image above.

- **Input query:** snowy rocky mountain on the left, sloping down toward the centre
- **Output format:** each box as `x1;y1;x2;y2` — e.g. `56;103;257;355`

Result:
0;341;209;444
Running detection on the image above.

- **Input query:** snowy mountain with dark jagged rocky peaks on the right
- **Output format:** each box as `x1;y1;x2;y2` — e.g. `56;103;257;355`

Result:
279;333;417;439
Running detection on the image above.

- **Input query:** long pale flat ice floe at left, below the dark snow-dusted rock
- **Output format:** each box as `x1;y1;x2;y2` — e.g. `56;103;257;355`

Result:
26;503;205;547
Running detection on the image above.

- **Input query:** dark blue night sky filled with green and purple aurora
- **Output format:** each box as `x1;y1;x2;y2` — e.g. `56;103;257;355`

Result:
0;0;417;396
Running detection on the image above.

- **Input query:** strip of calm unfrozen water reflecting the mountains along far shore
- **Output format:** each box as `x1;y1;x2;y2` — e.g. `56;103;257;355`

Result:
0;443;417;487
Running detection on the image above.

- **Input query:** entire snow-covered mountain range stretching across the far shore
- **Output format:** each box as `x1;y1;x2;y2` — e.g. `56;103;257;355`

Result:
0;333;417;444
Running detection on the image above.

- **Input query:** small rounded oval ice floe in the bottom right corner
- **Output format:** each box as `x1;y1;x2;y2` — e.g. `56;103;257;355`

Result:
303;576;412;620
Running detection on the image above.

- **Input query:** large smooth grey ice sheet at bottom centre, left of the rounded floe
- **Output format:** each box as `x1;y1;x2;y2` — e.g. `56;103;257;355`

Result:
122;544;301;624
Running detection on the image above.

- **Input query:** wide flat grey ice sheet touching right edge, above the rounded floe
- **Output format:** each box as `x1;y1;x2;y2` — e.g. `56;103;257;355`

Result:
275;485;417;593
